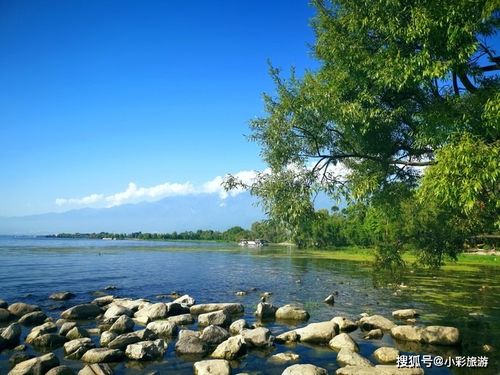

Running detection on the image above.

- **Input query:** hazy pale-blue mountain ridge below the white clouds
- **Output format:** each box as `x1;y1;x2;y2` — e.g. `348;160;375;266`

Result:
0;193;265;234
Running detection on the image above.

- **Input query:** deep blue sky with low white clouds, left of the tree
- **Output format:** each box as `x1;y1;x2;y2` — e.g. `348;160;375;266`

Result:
0;0;315;216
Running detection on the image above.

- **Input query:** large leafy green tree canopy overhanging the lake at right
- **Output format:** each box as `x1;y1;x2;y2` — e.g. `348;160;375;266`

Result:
227;0;500;266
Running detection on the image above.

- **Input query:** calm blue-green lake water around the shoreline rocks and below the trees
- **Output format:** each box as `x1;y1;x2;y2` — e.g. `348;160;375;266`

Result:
0;237;500;374
